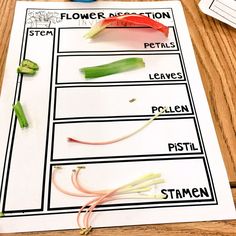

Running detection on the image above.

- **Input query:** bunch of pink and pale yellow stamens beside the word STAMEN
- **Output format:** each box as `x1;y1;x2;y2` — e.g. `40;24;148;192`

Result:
52;167;164;234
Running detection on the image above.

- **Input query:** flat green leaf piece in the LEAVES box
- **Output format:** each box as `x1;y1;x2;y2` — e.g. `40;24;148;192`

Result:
80;57;145;79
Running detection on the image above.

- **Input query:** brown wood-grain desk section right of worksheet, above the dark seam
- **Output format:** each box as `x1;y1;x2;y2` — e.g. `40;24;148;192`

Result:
179;0;236;186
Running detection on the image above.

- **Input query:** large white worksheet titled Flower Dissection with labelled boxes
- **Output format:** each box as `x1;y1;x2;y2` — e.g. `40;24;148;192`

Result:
0;1;235;232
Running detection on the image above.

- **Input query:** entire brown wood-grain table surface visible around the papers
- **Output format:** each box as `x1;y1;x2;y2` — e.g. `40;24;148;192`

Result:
0;0;236;236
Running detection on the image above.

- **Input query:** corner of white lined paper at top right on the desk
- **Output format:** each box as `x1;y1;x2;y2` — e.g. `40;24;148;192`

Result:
199;0;236;28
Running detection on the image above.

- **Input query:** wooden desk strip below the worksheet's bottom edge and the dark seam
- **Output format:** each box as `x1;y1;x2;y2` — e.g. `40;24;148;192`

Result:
2;189;236;236
